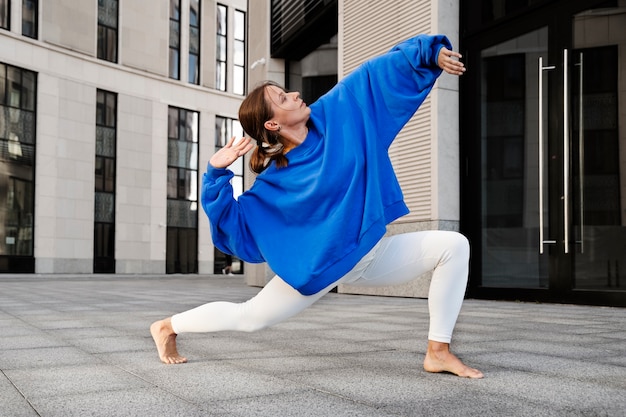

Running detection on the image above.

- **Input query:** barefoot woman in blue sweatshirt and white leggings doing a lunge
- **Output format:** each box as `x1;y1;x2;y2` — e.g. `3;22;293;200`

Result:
151;35;483;378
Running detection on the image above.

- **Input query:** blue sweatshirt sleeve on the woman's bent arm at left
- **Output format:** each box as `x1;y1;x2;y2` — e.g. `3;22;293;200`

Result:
201;165;265;263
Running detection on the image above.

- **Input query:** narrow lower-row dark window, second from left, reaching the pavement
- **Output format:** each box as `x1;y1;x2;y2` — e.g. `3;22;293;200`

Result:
93;90;117;273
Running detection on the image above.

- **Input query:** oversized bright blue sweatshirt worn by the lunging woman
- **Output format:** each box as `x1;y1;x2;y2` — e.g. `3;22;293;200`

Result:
201;35;452;295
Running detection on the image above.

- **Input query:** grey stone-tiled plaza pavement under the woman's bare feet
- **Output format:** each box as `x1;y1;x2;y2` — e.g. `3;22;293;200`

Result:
0;275;626;417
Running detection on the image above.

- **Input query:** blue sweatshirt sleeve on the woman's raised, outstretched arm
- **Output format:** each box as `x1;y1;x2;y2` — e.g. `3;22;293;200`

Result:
342;35;452;147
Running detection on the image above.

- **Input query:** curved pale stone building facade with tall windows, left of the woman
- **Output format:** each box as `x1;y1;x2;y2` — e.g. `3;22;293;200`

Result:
0;0;247;274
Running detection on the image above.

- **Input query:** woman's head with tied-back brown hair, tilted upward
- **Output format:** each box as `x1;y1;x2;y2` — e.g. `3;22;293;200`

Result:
239;81;310;173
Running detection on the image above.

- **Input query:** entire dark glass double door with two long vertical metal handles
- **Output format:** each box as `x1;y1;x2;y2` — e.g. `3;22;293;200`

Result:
463;2;626;306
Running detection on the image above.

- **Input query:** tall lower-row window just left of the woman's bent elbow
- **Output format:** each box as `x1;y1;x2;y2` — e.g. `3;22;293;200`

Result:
166;107;200;274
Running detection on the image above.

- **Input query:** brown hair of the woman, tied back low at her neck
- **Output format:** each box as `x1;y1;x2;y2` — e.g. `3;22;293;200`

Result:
239;81;289;174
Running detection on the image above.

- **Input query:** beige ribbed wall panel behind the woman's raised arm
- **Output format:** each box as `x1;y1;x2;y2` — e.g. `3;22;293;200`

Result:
342;0;432;223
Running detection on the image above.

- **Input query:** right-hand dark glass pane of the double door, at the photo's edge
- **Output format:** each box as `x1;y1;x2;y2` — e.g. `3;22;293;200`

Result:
564;8;626;291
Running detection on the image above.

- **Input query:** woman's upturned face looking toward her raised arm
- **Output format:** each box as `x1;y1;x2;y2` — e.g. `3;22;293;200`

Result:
265;85;311;128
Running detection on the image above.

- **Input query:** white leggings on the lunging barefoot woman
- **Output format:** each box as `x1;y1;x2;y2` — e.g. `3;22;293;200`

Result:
172;231;469;343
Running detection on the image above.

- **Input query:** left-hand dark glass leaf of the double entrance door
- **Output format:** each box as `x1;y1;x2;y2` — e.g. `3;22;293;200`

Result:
480;26;549;288
